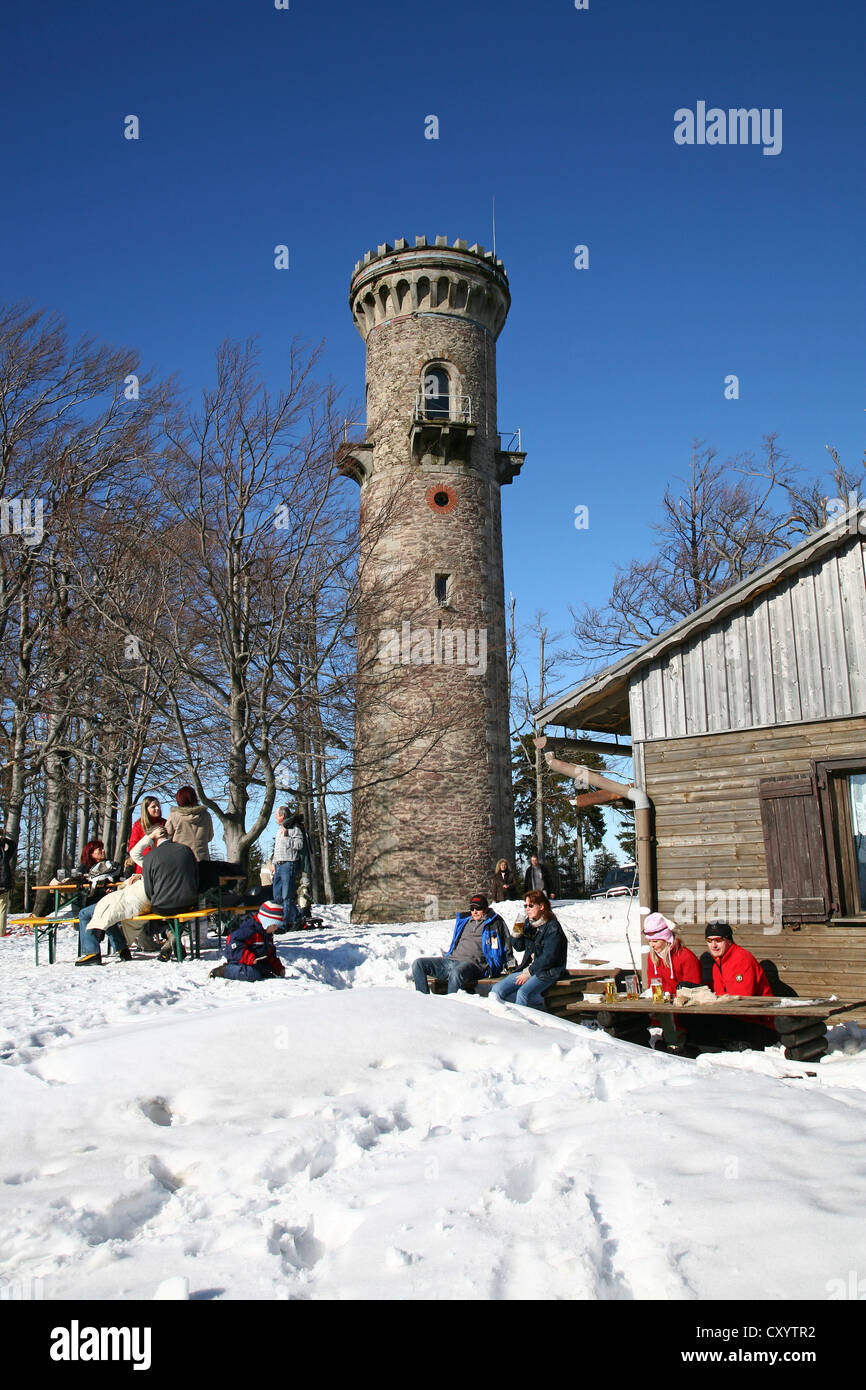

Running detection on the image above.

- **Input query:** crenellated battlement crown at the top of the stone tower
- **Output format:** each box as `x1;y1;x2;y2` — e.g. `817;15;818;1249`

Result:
349;236;512;339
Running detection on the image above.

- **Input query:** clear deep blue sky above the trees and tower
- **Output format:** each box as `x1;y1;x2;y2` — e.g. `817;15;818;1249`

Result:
0;0;866;717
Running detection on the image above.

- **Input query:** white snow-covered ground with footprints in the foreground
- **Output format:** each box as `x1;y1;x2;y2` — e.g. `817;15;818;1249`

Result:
0;899;866;1300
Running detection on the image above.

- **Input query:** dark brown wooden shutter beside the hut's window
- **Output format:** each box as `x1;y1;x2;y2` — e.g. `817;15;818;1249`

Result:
758;773;830;922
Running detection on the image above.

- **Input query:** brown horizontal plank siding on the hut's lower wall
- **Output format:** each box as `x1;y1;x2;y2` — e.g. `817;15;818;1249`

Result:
644;716;866;998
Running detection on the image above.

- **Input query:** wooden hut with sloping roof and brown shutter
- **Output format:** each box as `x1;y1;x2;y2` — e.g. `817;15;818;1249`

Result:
537;509;866;998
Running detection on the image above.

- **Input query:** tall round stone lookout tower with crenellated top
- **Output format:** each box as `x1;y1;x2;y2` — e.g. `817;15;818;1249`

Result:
339;236;524;922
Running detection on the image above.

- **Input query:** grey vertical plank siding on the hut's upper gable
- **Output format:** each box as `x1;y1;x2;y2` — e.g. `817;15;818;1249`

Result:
630;537;866;742
